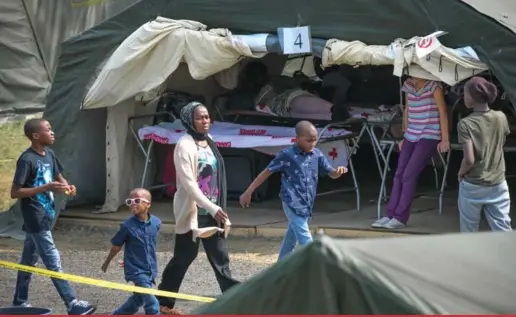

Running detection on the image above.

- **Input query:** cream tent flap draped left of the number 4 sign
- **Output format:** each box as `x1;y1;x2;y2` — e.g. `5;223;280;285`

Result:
84;17;265;109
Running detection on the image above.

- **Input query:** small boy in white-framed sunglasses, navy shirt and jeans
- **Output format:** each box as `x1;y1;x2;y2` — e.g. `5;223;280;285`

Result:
102;188;161;315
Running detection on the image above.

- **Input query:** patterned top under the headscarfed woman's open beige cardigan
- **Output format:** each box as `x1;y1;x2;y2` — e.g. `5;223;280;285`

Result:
197;145;219;215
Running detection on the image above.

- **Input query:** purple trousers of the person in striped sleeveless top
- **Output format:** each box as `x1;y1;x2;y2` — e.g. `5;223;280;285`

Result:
387;139;439;224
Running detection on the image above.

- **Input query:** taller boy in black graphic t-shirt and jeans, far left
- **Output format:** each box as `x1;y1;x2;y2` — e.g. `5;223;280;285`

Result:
11;119;96;315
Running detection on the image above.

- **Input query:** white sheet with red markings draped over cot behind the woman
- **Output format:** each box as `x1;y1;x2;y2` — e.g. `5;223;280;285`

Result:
138;120;351;166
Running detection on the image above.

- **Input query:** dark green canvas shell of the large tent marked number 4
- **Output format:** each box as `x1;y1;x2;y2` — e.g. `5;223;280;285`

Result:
0;0;516;237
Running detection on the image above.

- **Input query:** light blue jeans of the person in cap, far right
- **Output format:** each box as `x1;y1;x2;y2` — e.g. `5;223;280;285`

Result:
458;180;512;232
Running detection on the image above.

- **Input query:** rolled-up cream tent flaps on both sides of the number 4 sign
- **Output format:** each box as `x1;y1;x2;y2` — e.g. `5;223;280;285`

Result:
83;17;487;109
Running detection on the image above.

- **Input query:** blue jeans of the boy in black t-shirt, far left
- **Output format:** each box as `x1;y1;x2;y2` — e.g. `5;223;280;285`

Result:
13;231;76;308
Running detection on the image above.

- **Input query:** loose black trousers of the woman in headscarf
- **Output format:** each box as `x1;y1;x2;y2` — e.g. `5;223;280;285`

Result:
157;215;239;308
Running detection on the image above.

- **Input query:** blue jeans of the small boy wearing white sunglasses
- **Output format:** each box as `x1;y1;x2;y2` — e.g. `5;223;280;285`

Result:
113;276;159;315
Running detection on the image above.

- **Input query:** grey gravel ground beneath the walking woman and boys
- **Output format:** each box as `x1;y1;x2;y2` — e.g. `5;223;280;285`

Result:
0;229;280;314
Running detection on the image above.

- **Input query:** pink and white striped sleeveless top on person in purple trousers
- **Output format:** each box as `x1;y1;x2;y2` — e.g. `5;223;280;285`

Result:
401;79;441;142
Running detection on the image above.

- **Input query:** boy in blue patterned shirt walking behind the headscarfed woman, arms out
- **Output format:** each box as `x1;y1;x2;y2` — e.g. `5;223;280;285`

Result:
240;121;347;260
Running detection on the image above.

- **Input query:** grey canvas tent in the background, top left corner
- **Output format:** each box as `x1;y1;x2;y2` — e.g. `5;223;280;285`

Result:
0;0;139;114
